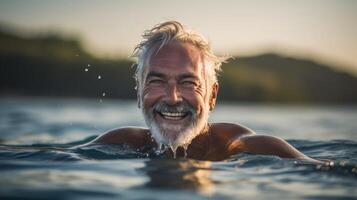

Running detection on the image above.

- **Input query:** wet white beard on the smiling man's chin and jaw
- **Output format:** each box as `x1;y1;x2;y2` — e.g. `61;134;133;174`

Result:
141;101;209;154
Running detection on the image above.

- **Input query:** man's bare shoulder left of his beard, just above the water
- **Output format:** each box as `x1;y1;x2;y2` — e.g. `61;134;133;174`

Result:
89;127;151;147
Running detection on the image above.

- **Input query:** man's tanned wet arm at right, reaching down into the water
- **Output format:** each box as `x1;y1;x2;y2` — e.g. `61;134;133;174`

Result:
231;135;322;163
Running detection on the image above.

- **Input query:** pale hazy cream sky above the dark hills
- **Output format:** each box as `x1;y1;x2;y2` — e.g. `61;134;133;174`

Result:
0;0;357;75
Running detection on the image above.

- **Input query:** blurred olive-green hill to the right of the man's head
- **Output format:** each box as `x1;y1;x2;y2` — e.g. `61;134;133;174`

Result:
221;54;357;103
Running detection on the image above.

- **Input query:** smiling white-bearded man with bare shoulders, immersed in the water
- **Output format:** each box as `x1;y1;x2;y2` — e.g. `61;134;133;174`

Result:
86;21;315;161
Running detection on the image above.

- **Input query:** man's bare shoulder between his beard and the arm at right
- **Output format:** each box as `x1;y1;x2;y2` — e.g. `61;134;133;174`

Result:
211;123;255;139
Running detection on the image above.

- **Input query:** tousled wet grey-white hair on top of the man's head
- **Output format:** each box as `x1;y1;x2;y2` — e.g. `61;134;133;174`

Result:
132;21;227;95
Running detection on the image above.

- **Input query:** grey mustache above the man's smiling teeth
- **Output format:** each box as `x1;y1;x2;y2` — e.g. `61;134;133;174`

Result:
153;101;196;115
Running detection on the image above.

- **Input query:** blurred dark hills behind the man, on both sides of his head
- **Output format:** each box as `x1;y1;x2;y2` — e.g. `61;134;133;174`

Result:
0;28;357;103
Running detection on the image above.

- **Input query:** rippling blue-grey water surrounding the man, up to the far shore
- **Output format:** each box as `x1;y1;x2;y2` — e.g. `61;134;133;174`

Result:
0;98;357;200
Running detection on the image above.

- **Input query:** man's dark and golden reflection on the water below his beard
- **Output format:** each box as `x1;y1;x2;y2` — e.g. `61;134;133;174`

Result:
140;159;214;195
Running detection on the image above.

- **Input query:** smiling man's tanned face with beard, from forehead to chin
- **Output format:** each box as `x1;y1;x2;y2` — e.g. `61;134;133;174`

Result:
140;42;217;146
